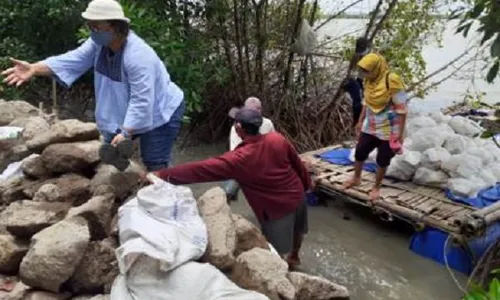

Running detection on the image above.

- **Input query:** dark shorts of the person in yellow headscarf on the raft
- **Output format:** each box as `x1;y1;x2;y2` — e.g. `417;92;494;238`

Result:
354;132;396;168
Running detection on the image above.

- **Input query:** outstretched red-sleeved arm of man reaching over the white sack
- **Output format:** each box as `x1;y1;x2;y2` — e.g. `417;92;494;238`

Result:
154;152;237;184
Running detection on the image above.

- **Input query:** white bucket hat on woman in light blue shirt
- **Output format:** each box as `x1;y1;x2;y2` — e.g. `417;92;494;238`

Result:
82;0;130;23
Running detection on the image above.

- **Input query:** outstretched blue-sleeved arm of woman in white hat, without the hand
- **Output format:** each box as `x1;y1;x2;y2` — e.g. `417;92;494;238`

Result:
42;39;98;88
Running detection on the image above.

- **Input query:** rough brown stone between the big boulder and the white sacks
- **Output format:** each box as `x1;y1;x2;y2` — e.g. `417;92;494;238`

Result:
69;241;119;294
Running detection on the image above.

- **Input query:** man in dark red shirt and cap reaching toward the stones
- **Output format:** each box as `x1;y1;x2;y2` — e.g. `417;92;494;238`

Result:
150;108;311;268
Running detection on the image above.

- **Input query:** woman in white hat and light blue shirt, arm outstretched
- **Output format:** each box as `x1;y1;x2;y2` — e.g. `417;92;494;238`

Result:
2;0;185;171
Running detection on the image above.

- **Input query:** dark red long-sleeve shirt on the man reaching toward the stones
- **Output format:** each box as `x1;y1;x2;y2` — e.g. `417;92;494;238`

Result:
158;132;311;220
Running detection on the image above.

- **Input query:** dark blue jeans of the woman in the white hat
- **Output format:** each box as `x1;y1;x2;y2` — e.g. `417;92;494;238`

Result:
102;101;186;171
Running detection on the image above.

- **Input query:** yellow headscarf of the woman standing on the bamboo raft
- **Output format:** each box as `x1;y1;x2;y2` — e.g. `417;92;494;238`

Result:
358;53;404;114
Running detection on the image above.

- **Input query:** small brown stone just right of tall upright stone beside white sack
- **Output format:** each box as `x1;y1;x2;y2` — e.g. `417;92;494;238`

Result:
232;214;270;257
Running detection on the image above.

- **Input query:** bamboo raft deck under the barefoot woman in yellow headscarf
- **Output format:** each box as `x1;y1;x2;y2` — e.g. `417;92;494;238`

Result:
301;143;500;239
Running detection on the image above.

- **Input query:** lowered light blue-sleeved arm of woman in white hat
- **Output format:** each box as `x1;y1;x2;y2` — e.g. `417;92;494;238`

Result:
123;58;156;134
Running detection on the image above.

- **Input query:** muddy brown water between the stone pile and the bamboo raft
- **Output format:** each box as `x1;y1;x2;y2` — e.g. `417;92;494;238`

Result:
173;144;466;300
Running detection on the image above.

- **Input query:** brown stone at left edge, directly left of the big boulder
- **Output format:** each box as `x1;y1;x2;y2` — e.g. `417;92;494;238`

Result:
0;234;29;274
